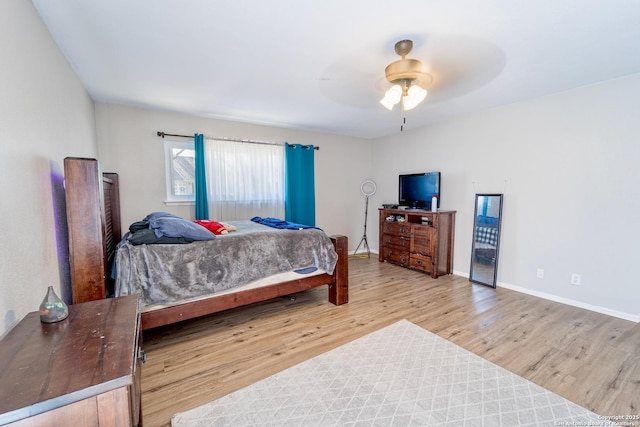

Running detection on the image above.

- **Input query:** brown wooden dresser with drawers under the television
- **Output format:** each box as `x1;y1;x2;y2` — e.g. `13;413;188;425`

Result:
378;208;456;279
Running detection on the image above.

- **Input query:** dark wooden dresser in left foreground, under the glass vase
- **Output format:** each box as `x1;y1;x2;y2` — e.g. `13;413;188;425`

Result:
0;295;143;427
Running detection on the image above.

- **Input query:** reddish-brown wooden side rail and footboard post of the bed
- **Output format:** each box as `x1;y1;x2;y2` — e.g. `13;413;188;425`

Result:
141;236;349;330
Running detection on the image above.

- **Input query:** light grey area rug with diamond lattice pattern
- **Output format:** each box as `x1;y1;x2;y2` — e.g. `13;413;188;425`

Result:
171;320;604;427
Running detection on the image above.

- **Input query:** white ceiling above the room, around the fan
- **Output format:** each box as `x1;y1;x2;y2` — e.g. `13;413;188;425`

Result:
33;0;640;138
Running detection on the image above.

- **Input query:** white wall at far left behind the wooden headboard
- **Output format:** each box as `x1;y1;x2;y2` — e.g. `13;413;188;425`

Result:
0;1;97;336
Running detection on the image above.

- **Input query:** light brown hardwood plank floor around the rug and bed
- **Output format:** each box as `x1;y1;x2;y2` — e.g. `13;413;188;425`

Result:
142;257;640;426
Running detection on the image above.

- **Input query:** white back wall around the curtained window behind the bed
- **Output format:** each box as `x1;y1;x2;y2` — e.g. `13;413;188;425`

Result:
96;103;371;249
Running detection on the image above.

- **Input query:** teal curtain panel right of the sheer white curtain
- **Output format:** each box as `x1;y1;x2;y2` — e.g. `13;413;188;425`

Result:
284;144;316;227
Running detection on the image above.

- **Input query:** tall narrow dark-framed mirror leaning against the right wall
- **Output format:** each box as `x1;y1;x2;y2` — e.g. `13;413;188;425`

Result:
469;194;502;288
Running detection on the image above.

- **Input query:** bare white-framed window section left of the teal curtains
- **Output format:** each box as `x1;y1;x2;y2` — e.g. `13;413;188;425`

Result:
164;140;196;203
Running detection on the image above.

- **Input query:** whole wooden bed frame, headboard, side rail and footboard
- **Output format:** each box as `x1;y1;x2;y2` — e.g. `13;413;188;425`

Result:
64;157;349;330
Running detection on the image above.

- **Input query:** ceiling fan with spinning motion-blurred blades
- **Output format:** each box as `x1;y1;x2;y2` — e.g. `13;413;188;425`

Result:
318;33;506;134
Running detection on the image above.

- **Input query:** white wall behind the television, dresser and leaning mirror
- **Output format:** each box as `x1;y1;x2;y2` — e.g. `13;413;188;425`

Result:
372;74;640;321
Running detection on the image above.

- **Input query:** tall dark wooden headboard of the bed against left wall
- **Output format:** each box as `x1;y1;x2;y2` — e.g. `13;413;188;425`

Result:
64;157;122;304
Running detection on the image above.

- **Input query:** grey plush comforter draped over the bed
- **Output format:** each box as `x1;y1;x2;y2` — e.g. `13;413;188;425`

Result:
116;221;338;306
